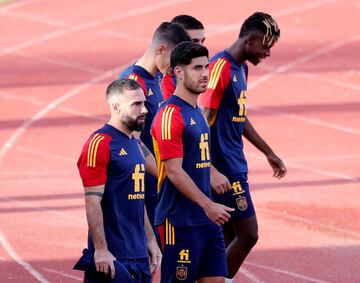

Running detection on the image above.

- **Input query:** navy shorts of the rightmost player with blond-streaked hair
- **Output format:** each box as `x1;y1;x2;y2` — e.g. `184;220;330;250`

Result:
213;173;255;221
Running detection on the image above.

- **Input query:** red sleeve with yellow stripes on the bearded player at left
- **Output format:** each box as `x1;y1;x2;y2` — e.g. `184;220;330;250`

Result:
77;134;111;187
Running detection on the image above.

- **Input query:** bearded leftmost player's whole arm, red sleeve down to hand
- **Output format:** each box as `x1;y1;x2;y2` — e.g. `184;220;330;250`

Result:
77;134;116;278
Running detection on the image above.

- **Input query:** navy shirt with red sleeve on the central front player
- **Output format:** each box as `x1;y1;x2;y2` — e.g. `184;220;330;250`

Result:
151;95;212;227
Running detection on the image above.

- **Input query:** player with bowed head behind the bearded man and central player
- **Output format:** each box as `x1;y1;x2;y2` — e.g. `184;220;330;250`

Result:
119;22;190;231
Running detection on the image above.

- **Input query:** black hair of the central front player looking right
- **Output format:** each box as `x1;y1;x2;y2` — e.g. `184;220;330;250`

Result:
170;41;209;69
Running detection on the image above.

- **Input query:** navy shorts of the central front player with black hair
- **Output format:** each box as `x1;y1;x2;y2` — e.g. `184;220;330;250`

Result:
157;223;227;283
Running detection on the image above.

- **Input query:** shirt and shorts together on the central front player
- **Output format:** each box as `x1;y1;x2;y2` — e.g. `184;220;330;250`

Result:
151;95;227;283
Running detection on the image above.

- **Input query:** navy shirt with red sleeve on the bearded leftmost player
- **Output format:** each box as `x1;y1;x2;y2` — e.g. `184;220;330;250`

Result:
77;124;148;259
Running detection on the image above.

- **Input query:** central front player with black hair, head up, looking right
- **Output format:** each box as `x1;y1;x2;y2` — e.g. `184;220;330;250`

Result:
151;42;232;283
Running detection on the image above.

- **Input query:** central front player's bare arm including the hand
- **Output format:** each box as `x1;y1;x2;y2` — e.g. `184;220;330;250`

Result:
164;158;234;225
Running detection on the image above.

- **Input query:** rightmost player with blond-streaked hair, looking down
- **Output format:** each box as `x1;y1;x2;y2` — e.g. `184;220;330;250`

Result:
199;12;286;282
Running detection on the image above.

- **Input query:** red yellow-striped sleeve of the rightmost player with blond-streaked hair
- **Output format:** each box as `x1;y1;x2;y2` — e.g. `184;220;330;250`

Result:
198;58;231;110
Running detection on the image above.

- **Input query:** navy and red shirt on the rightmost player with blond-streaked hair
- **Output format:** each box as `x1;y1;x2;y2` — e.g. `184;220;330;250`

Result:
198;51;248;176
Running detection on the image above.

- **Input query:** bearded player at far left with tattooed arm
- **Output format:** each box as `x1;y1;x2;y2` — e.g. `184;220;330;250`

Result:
74;79;161;283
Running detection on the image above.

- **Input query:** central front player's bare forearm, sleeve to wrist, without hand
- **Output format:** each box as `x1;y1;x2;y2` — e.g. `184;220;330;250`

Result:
166;162;211;209
